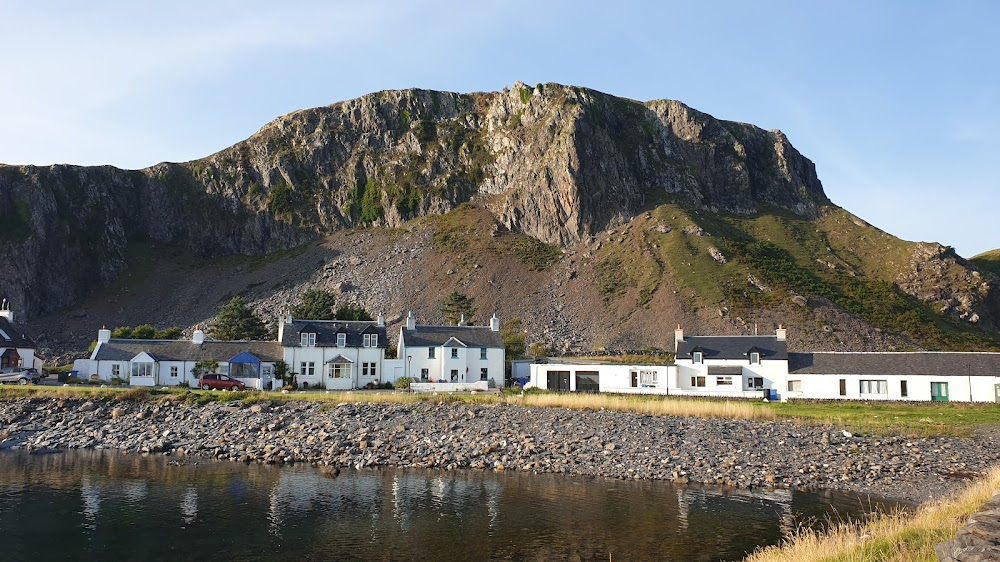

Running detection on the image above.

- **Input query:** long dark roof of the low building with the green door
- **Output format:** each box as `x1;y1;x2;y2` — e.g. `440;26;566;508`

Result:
788;351;1000;377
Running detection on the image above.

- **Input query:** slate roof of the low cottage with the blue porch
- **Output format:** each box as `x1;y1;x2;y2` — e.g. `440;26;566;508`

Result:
94;339;284;362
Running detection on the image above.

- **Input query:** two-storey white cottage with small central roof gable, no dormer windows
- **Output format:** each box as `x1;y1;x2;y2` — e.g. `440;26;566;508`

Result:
396;310;505;386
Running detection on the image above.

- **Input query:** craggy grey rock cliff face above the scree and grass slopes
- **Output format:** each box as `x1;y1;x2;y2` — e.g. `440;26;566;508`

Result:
0;83;828;318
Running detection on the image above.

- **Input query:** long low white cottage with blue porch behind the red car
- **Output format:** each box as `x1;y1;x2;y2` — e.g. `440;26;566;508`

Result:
85;328;282;388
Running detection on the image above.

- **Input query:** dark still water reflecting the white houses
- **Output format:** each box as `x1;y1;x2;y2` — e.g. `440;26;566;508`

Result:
0;451;908;561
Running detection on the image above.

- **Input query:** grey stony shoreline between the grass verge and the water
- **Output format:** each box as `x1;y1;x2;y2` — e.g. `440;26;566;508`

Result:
0;395;1000;502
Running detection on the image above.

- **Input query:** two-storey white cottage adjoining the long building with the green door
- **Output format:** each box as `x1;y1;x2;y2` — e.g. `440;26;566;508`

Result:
672;326;788;400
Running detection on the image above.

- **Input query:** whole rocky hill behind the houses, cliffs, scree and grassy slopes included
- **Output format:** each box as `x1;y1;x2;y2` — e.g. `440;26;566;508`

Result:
0;83;1000;350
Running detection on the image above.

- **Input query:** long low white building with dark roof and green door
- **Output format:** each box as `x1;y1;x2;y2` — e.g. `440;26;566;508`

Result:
785;351;1000;402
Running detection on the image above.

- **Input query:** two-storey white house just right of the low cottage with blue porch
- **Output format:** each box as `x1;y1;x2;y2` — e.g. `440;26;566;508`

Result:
278;315;394;390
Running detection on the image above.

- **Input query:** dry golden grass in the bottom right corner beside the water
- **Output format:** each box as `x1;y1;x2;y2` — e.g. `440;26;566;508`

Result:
746;467;1000;562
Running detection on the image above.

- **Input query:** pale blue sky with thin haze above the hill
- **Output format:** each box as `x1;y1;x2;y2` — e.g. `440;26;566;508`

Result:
0;0;1000;257
